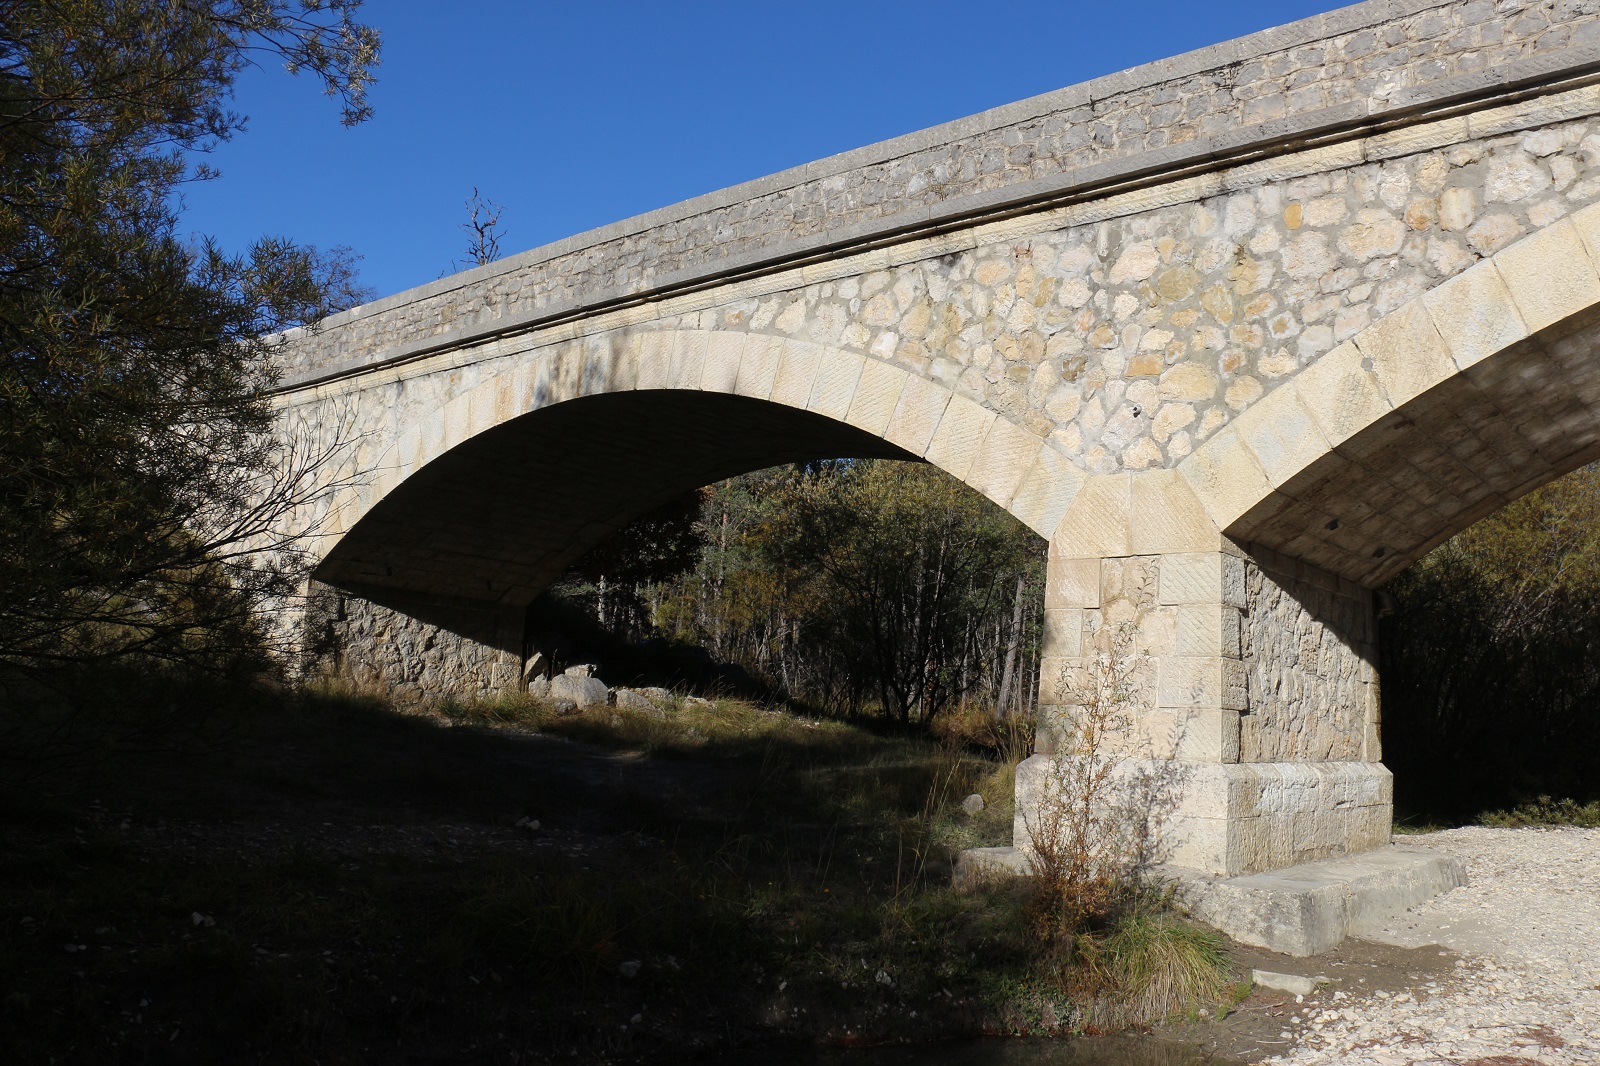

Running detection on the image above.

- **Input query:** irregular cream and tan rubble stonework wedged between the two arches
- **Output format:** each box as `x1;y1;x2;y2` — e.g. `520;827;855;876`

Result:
688;109;1600;474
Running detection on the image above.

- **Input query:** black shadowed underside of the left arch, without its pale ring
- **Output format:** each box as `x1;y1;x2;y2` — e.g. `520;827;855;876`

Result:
315;389;920;605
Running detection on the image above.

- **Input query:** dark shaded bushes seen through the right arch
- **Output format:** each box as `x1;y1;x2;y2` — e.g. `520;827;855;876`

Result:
1379;466;1600;821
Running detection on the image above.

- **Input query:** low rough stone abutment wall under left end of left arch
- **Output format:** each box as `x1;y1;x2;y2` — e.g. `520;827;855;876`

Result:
304;581;526;704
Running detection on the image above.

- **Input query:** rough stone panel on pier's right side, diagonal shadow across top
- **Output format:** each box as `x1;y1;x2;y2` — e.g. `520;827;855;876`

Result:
1240;549;1379;762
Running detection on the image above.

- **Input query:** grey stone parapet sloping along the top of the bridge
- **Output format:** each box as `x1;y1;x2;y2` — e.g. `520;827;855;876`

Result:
278;0;1600;389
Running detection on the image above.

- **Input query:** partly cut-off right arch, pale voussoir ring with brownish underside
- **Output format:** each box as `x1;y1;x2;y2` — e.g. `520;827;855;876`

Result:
1179;205;1600;587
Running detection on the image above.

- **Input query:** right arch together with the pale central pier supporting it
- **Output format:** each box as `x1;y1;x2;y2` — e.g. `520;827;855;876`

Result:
1018;206;1600;874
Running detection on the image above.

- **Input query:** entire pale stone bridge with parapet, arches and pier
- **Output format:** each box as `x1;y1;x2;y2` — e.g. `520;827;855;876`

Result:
277;0;1600;876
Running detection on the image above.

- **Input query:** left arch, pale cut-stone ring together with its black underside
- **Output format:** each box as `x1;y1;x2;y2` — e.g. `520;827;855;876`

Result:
302;330;1083;608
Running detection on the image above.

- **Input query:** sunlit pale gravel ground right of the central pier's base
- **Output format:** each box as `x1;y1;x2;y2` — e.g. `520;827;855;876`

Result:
1267;828;1600;1066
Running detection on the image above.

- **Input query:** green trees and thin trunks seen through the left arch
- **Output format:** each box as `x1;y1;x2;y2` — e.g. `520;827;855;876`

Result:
555;459;1046;727
